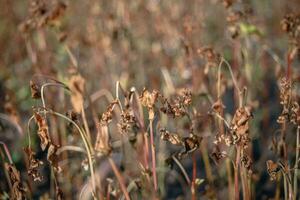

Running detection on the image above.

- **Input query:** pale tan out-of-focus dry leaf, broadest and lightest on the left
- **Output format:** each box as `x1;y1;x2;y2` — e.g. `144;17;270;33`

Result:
69;74;85;113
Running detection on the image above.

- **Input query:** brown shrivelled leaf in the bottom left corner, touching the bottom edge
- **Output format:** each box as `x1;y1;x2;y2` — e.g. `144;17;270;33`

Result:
5;163;25;200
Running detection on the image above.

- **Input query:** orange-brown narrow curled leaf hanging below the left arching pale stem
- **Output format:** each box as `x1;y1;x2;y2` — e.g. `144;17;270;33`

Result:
34;112;51;151
